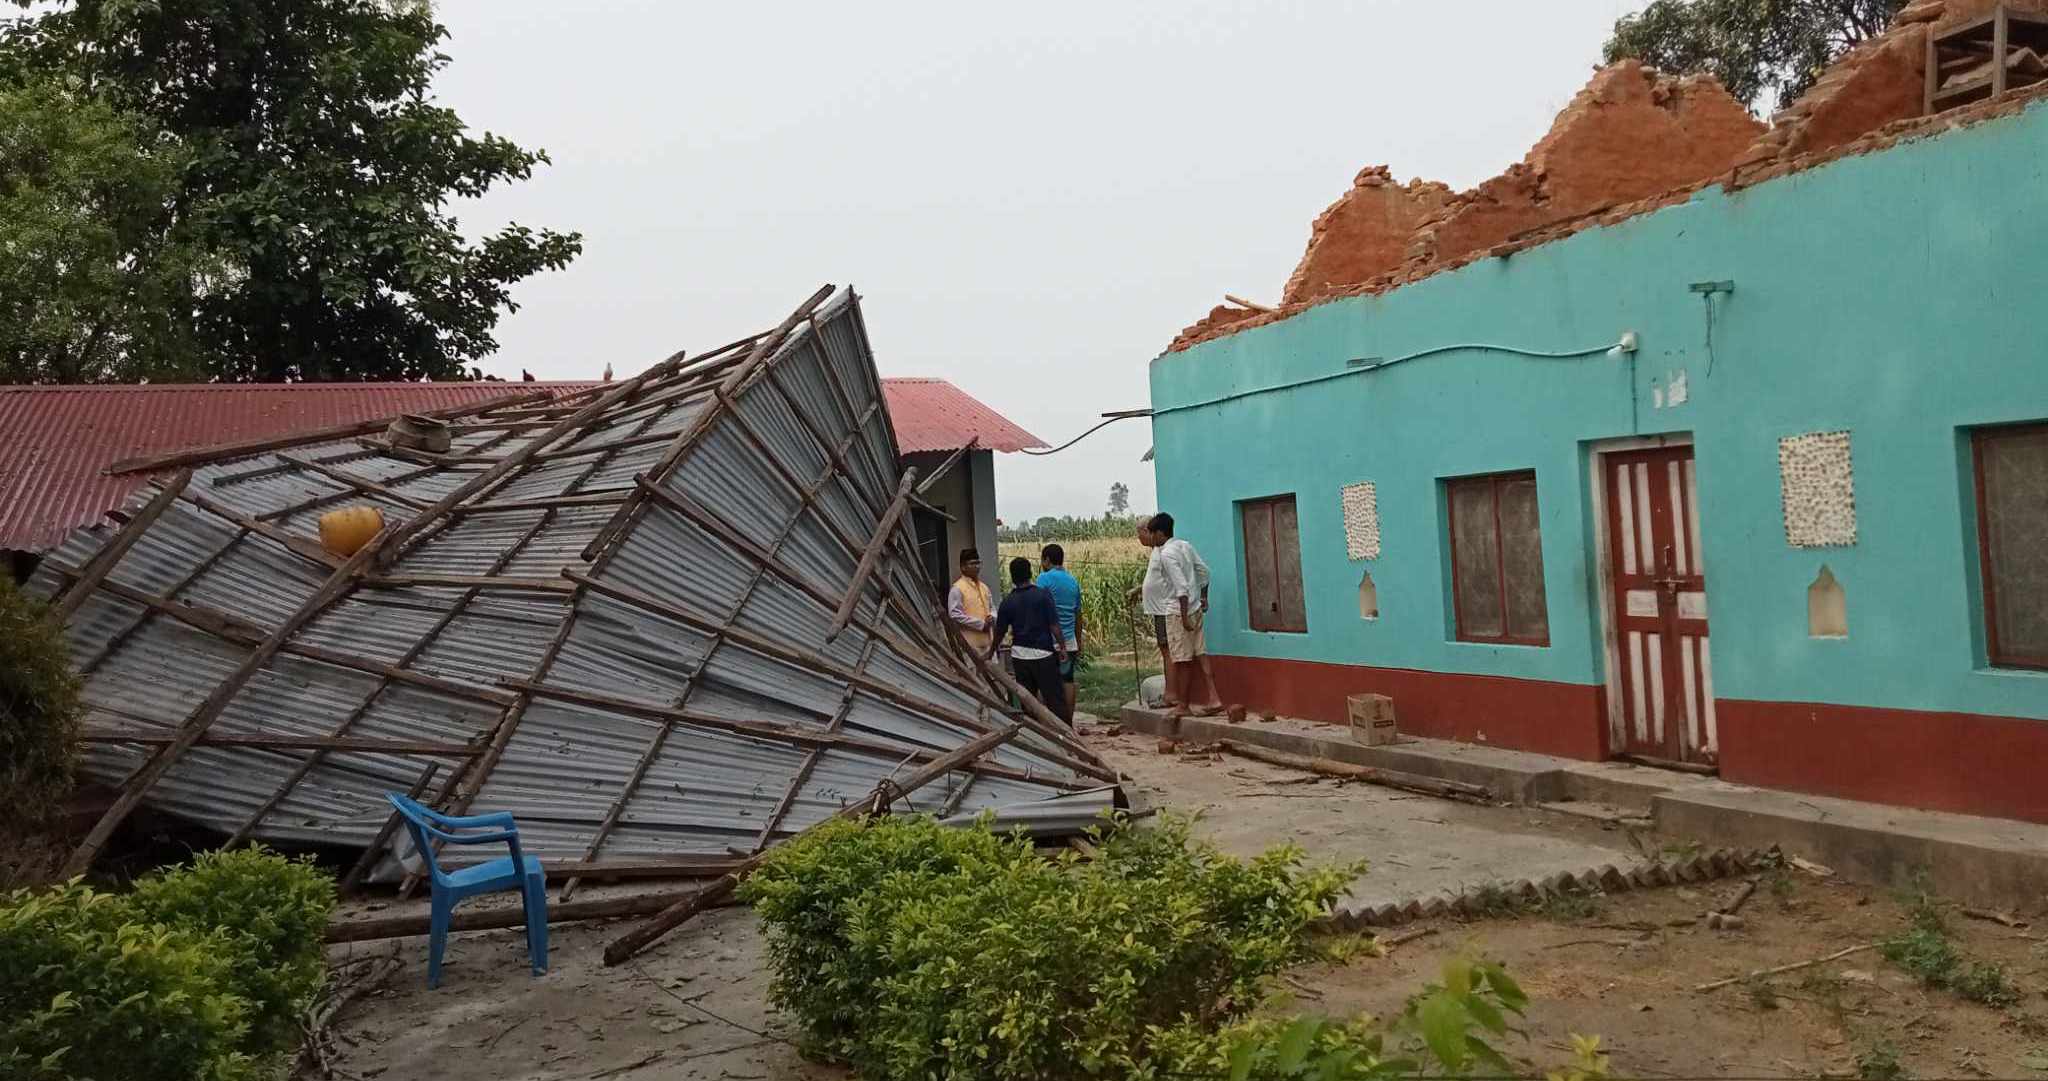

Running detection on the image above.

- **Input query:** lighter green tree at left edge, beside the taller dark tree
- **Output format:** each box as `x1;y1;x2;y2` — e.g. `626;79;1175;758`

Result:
0;73;223;383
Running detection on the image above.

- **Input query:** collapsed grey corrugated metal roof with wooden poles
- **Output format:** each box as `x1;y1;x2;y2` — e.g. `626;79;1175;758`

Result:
31;289;1116;878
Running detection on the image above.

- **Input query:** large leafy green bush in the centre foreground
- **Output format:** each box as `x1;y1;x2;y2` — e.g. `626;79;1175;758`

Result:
743;819;1360;1079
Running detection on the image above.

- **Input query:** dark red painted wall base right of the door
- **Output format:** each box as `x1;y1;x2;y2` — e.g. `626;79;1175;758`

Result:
1714;698;2048;821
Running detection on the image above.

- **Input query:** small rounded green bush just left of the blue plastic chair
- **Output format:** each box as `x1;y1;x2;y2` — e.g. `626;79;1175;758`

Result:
129;848;334;1054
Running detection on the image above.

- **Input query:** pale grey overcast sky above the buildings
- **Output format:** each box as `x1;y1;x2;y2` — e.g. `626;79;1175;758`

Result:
438;0;1640;522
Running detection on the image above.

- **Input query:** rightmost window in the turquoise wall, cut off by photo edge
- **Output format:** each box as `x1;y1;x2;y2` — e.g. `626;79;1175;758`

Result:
1970;424;2048;667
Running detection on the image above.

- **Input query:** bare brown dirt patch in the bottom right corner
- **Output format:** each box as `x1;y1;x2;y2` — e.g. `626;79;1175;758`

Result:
1286;872;2048;1077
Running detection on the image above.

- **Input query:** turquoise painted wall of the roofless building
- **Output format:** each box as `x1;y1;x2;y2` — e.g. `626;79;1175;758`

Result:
1151;104;2048;719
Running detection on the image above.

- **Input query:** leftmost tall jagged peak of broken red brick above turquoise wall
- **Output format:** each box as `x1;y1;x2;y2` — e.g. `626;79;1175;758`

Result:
1280;166;1450;303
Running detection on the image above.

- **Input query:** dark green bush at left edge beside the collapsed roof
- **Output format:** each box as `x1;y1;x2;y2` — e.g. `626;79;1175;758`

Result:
0;577;80;835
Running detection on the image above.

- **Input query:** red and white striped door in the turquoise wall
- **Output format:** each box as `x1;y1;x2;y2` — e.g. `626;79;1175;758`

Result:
1602;446;1718;764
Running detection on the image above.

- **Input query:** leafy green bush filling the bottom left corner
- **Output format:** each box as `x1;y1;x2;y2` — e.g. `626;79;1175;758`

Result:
0;882;262;1081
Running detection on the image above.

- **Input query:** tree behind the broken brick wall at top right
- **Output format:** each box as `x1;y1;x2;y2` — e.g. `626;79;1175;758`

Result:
1604;0;1905;113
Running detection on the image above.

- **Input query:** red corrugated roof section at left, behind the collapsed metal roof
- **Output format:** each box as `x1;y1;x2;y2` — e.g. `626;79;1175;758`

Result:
0;383;588;551
